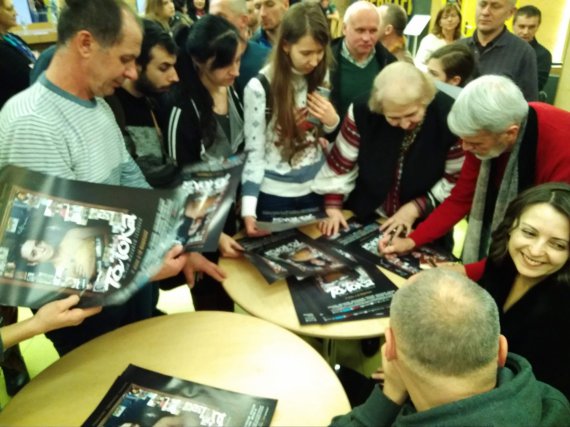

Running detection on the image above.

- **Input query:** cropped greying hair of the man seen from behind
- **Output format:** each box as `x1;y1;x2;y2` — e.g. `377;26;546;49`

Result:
390;268;500;377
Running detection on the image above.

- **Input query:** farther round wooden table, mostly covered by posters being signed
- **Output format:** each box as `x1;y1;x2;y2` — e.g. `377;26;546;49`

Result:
220;225;404;339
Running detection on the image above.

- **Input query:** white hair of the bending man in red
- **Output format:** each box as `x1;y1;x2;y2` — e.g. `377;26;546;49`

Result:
447;74;528;137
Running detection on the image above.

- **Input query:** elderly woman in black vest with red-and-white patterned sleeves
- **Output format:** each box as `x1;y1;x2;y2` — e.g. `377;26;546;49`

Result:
313;62;463;244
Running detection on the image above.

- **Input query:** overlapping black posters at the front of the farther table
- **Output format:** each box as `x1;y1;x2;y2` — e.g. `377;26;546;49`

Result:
240;230;396;325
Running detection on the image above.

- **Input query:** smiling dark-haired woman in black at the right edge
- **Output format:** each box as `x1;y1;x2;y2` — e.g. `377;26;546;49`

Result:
481;183;570;397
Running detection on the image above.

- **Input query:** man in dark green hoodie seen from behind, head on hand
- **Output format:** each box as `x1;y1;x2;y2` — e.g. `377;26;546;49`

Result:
332;269;570;426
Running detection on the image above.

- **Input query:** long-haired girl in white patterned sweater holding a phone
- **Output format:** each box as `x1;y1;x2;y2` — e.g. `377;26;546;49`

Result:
242;3;339;236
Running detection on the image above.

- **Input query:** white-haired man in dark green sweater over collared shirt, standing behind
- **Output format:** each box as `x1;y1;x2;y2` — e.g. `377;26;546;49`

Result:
330;0;396;123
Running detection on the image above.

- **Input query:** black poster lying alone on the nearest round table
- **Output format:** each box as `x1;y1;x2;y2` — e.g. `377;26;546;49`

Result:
83;365;277;427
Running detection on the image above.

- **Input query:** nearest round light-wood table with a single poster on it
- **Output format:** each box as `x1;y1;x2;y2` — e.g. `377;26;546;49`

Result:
0;311;350;426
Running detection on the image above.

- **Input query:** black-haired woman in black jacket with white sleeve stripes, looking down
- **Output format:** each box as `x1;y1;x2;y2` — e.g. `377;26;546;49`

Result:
167;15;245;311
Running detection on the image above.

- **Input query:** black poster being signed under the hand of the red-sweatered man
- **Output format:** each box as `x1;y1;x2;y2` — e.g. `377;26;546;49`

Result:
320;218;459;278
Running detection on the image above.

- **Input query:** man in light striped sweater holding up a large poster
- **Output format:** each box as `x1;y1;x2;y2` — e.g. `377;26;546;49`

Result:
0;0;223;355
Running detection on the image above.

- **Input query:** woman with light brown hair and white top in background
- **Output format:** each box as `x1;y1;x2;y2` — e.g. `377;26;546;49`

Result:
414;3;461;71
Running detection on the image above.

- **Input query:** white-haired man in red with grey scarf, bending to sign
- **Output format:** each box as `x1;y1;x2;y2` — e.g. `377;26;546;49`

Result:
380;75;570;280
